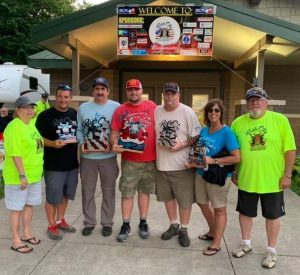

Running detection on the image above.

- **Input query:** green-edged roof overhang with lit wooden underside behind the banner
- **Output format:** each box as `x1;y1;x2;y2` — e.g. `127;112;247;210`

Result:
32;0;300;68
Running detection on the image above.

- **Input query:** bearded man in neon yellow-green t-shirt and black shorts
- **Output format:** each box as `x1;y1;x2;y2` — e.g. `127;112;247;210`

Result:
232;87;296;268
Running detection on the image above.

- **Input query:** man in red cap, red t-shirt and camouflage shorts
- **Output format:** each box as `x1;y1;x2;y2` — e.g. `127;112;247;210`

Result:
110;79;156;242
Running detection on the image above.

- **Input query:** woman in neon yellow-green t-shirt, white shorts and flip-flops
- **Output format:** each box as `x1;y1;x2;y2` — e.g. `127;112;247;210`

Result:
3;96;44;253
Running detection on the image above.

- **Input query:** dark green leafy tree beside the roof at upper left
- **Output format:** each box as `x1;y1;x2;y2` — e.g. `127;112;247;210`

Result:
0;0;88;64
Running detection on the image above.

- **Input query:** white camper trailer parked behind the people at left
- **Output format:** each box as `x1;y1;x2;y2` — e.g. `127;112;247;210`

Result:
0;63;50;107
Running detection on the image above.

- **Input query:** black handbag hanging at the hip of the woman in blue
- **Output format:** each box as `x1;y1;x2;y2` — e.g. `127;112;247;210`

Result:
202;148;235;186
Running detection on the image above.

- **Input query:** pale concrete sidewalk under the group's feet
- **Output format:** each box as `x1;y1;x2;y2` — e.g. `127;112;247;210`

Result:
0;181;300;275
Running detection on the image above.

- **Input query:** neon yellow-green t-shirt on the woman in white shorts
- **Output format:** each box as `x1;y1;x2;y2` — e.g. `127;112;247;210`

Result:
3;118;44;185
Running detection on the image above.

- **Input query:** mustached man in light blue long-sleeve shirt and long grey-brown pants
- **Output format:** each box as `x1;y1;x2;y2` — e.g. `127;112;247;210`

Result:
77;77;120;237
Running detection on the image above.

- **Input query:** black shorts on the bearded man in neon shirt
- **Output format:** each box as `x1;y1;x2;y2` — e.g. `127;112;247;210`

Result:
236;190;285;220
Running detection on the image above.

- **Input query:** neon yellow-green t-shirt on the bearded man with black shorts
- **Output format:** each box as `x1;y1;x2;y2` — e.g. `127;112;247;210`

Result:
231;111;296;194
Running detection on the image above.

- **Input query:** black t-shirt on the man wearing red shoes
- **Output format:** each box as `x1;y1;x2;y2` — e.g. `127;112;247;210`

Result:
36;107;78;171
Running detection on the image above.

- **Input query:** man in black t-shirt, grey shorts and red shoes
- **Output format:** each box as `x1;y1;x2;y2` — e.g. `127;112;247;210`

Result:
36;85;78;240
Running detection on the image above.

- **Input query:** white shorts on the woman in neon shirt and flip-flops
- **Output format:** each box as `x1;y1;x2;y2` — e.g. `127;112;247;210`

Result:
4;182;42;211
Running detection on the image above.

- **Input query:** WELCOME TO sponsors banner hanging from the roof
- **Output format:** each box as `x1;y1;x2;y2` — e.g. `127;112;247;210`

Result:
117;6;215;56
